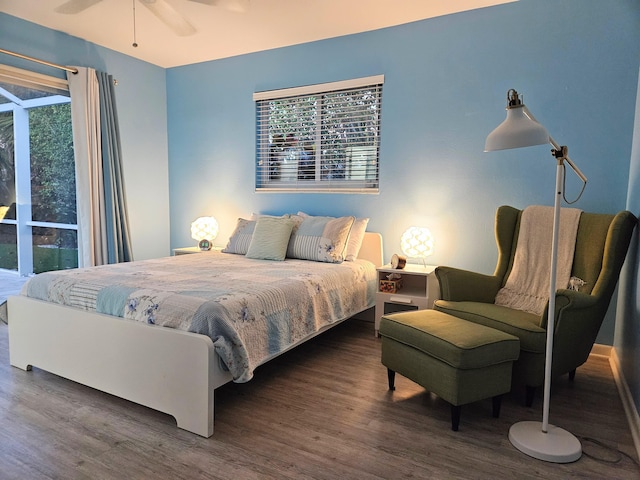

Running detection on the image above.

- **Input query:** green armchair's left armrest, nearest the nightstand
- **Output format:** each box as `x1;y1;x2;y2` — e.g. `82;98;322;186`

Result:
435;267;501;303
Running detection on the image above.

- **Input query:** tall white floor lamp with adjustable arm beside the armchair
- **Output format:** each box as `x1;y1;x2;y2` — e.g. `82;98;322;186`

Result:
485;89;587;463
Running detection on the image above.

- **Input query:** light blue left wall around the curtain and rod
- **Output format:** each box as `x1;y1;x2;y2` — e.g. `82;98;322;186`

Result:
0;13;170;260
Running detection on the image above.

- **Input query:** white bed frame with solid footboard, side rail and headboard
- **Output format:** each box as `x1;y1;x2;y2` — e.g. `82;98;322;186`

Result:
8;232;382;437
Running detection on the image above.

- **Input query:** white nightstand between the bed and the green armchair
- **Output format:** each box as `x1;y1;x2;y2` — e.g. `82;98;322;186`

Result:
375;263;440;336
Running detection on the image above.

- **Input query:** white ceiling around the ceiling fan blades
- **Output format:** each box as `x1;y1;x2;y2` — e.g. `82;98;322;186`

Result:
0;0;516;68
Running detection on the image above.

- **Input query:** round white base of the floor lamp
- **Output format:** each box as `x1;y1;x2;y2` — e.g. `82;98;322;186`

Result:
509;422;582;463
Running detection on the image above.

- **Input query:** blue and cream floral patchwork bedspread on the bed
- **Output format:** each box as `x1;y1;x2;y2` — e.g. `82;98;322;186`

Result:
22;252;377;382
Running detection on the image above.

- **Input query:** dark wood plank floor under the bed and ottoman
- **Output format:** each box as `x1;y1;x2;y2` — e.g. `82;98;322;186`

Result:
0;320;640;480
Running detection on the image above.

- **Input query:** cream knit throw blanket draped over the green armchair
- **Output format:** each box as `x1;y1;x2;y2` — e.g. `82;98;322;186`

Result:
495;205;582;315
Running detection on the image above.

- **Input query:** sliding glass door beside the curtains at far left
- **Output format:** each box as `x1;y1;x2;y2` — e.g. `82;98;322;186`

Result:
0;66;78;275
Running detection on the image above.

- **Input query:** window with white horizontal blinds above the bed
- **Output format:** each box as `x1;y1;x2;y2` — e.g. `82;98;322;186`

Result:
253;75;384;193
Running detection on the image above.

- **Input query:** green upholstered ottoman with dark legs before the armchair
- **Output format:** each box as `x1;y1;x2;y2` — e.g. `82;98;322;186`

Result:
380;310;520;431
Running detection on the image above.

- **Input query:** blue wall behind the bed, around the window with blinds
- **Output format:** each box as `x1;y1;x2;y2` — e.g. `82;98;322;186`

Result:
167;0;640;345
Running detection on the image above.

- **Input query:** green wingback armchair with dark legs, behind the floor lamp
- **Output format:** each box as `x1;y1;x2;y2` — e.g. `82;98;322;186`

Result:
434;206;637;406
